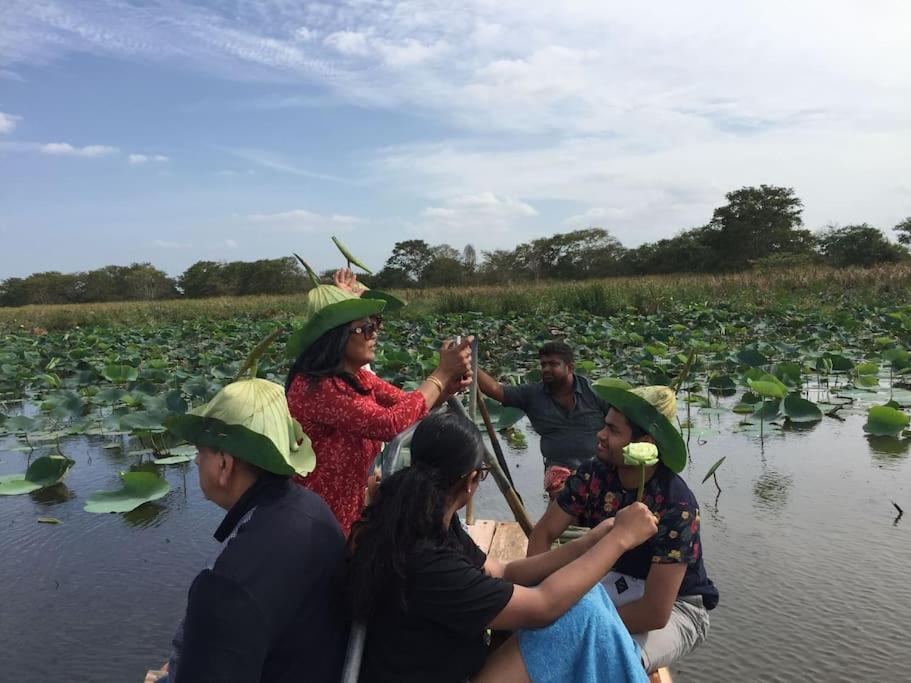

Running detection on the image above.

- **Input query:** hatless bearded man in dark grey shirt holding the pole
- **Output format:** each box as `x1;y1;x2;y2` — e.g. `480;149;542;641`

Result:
478;342;610;499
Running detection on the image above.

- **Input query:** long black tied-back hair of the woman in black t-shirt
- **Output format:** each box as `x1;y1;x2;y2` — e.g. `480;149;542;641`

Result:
347;412;484;619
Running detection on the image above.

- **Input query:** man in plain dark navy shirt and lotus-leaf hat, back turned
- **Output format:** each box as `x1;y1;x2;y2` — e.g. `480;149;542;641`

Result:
160;379;347;683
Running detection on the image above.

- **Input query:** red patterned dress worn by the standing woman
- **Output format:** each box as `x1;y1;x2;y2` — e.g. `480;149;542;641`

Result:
288;370;427;536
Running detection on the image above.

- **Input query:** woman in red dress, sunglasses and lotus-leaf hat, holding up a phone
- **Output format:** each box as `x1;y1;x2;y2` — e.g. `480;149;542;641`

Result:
285;298;471;534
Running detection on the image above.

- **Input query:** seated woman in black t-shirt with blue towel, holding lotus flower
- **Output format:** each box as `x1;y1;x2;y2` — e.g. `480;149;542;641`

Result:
348;413;656;683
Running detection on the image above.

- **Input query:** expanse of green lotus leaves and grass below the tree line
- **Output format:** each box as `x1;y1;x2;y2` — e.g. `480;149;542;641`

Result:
0;265;911;511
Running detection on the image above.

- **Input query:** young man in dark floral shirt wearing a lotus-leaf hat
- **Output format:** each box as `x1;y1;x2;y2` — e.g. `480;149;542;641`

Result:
528;386;718;672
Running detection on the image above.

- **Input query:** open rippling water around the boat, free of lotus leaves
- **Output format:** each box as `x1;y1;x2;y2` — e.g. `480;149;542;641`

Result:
0;407;911;683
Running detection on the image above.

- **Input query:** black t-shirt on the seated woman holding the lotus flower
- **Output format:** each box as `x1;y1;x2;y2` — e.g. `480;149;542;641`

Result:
360;516;513;683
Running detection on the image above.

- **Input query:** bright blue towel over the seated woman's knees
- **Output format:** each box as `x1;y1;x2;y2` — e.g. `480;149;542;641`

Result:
519;584;648;683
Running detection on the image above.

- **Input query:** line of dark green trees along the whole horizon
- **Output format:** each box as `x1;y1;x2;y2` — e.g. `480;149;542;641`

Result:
0;185;911;306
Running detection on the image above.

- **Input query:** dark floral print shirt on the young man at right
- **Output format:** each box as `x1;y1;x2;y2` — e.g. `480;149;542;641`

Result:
557;458;718;609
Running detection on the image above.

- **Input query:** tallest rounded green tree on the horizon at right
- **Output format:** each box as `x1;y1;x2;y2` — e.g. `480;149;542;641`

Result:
705;185;813;271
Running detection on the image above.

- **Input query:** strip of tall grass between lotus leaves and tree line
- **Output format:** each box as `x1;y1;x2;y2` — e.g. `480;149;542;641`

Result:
0;263;911;330
